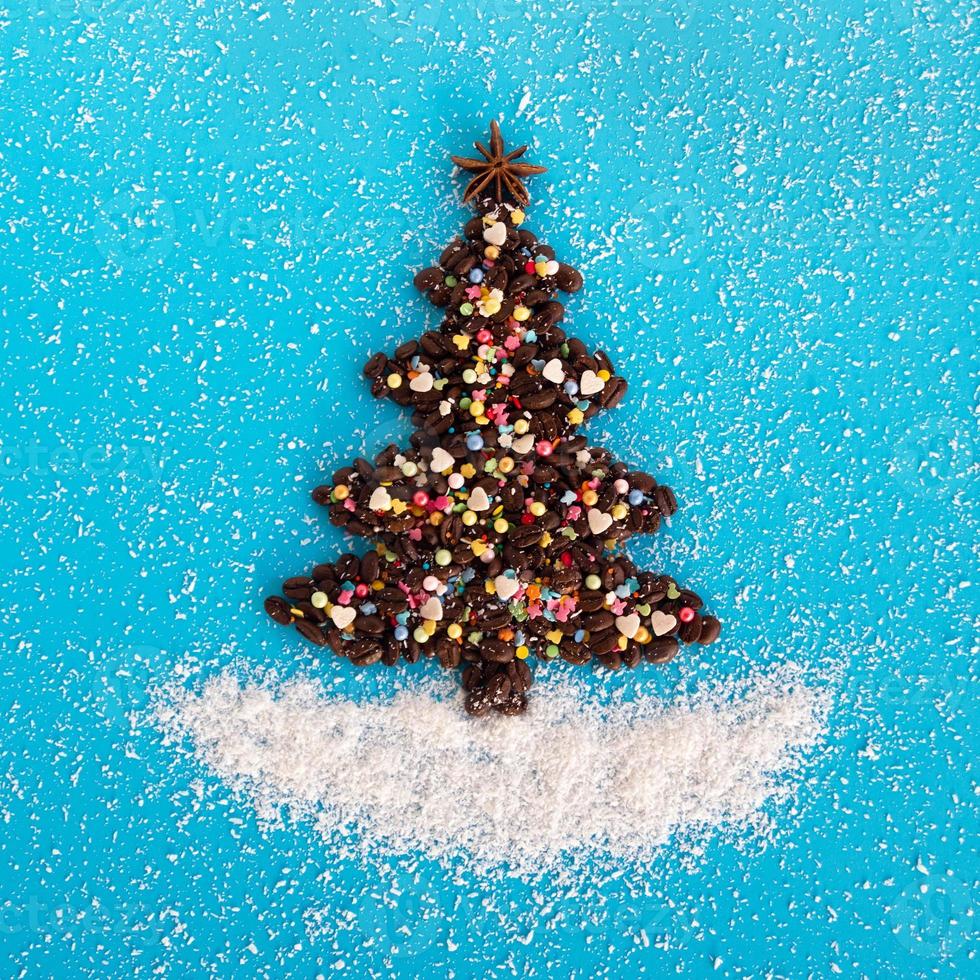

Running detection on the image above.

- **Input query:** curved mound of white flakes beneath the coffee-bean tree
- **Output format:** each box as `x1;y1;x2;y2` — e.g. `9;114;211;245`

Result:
155;668;827;876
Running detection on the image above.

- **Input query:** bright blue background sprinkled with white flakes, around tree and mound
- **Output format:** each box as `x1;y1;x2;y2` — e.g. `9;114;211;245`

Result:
0;0;980;977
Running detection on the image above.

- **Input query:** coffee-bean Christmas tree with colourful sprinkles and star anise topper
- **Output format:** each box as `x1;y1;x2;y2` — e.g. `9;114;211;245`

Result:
265;122;721;715
